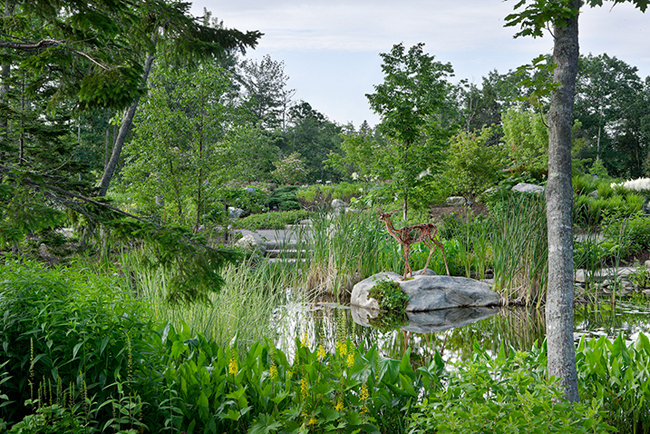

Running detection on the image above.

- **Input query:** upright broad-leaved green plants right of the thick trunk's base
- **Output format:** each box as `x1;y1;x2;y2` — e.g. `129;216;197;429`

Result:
576;333;650;434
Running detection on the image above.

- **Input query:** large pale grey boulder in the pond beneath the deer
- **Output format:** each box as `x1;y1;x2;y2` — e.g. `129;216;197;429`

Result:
350;272;502;312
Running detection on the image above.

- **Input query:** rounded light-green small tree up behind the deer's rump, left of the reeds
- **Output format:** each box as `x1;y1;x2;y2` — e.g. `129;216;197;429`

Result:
443;127;507;202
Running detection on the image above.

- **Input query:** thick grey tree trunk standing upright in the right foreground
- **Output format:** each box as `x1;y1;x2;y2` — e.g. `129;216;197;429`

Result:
546;0;581;402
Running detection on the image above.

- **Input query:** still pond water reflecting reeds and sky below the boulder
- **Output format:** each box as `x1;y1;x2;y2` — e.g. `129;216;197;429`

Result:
273;297;650;364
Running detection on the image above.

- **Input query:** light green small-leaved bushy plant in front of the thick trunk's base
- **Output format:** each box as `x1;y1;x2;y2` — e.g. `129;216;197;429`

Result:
408;347;613;434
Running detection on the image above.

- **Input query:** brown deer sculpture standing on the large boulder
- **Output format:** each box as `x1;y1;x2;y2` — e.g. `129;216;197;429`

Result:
379;211;449;280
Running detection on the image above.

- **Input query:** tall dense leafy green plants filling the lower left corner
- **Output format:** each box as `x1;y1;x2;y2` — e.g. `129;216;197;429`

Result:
0;261;159;433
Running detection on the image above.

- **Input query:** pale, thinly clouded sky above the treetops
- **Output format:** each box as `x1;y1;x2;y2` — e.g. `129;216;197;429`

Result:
190;0;650;127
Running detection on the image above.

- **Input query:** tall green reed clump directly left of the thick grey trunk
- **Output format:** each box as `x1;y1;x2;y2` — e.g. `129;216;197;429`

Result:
491;195;548;305
